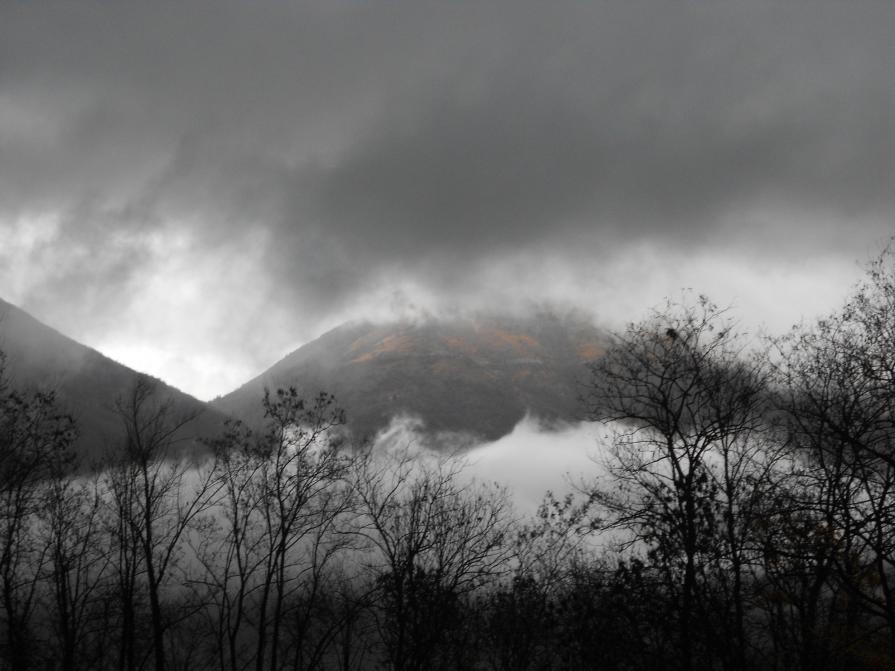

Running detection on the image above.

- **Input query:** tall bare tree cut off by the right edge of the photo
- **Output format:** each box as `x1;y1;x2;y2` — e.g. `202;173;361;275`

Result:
777;249;895;658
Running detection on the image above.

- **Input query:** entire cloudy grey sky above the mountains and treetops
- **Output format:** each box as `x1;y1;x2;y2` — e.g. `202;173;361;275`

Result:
0;0;895;399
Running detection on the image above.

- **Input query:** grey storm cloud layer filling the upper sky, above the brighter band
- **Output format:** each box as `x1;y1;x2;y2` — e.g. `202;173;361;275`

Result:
0;0;895;352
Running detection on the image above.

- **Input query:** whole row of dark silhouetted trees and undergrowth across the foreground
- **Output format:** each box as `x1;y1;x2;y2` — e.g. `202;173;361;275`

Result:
0;254;895;671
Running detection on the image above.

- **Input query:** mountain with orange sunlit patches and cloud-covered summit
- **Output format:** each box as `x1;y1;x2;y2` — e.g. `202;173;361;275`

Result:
212;312;607;440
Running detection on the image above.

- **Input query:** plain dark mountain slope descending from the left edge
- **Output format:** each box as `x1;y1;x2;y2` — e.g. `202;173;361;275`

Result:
0;300;224;463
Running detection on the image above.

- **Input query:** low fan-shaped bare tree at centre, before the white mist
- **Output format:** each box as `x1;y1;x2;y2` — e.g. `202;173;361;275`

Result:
355;451;513;671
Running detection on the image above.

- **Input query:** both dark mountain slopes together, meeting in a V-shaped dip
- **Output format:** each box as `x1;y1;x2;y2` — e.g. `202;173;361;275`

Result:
0;299;609;460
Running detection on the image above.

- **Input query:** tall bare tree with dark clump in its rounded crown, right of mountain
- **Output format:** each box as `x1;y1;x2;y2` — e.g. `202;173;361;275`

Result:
588;297;773;670
